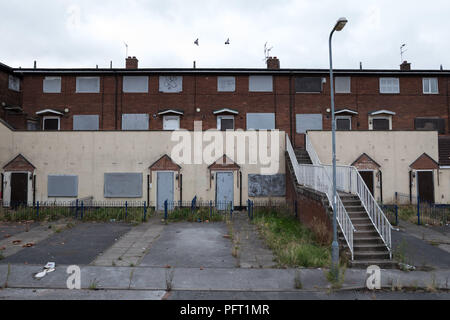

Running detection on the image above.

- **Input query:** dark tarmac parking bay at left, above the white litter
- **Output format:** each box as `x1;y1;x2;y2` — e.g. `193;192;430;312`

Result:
0;223;132;266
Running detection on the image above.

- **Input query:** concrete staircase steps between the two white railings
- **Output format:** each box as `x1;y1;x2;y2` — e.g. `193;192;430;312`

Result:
287;149;396;268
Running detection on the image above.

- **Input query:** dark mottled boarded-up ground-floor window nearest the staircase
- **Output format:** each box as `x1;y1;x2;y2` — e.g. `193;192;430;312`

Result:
248;174;286;197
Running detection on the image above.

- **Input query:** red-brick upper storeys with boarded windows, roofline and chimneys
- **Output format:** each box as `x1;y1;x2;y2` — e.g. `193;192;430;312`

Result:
0;57;450;147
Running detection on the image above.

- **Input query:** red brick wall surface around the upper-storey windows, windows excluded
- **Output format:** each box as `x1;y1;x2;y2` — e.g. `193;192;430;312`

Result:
3;73;450;146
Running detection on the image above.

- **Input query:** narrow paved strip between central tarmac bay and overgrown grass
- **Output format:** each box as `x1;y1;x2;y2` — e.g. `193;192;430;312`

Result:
233;212;277;268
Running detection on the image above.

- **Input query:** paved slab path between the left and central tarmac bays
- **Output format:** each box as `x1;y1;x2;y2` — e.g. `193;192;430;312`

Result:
91;217;165;267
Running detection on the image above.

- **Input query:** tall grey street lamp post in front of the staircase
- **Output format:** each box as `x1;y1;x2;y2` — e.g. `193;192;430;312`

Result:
328;18;347;279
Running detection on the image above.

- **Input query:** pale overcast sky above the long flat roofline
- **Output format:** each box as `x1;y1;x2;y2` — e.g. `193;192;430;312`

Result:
0;0;450;69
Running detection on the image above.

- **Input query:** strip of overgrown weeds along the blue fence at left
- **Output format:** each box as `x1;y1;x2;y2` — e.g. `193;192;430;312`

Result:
0;206;154;223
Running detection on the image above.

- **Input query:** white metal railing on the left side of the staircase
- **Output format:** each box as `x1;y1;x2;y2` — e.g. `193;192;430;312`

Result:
286;135;356;260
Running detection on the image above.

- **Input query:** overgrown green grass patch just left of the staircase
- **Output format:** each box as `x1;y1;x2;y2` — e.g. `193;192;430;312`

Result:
253;207;331;267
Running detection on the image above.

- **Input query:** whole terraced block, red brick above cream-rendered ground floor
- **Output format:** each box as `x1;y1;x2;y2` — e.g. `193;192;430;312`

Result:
0;57;450;266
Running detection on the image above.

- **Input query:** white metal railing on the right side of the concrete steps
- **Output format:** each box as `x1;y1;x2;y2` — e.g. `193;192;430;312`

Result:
325;165;392;258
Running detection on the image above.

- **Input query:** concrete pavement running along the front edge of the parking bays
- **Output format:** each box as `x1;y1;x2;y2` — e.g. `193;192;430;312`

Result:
0;265;450;292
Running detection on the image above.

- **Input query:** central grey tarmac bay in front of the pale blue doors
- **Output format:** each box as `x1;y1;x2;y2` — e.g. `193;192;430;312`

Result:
140;222;236;268
